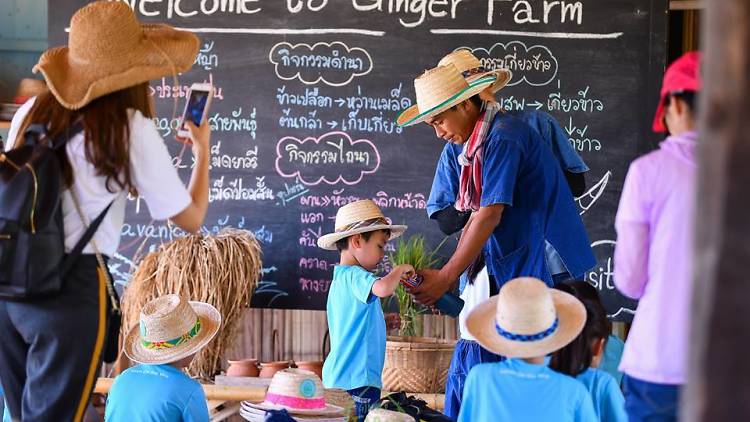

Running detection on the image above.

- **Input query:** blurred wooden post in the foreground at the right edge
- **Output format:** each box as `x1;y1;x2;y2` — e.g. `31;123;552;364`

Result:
681;0;750;422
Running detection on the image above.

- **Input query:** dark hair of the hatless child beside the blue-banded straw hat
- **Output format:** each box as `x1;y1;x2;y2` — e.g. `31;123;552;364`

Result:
549;281;612;377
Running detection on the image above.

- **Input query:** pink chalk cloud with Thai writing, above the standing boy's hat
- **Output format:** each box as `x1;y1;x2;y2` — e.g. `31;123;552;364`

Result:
276;131;380;186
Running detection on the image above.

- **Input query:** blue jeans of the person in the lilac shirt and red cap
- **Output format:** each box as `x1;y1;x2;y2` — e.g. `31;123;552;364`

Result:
622;374;680;422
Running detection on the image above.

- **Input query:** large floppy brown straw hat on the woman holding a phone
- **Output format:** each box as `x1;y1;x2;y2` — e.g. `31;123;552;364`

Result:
34;1;199;110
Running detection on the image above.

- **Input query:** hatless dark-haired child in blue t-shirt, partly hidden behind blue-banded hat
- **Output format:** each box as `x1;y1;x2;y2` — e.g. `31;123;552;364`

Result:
550;281;628;422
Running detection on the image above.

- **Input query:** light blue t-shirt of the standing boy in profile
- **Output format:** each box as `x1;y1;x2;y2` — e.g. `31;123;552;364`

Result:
323;265;385;390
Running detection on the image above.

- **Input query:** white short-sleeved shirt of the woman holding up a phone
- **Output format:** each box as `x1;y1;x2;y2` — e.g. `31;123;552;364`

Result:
6;98;192;257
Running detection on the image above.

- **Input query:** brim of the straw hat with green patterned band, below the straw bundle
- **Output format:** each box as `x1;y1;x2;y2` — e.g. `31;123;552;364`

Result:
124;302;221;365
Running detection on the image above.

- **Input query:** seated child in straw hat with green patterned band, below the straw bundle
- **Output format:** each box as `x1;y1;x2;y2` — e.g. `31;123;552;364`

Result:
105;295;221;422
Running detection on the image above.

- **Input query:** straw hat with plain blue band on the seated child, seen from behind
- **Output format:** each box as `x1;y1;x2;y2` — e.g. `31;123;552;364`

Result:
466;277;586;358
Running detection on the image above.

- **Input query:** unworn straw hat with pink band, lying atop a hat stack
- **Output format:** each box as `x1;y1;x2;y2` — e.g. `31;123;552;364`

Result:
247;369;344;416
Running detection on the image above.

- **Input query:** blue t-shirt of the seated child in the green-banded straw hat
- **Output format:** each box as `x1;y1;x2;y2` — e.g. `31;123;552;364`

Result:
104;365;209;422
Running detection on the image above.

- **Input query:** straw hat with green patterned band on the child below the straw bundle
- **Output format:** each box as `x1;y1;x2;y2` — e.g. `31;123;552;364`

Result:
124;295;221;365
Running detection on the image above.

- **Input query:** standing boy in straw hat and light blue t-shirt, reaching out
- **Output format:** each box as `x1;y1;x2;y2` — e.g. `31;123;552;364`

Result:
318;199;414;420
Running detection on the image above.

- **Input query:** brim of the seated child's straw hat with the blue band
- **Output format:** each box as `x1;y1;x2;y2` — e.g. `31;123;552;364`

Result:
466;290;586;358
